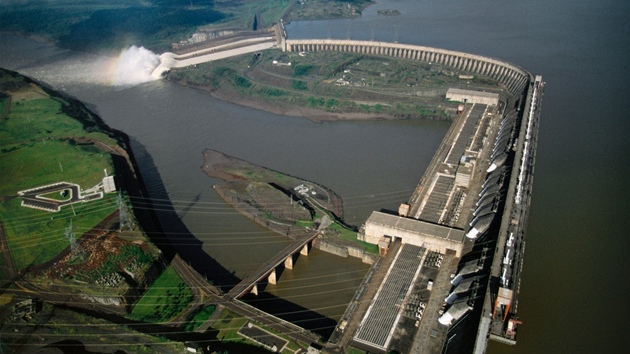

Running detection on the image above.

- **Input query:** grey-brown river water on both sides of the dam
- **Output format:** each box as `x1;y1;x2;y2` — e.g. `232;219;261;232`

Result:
0;0;630;353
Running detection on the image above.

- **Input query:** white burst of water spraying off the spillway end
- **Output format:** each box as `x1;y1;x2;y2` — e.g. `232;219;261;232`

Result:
109;46;160;86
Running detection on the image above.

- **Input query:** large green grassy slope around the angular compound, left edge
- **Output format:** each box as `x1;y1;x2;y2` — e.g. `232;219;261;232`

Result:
0;71;123;269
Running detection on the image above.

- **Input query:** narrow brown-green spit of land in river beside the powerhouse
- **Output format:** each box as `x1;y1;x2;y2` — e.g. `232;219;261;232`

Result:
202;149;377;257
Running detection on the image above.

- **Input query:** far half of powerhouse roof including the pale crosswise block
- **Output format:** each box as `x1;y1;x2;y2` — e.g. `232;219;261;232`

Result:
358;105;489;257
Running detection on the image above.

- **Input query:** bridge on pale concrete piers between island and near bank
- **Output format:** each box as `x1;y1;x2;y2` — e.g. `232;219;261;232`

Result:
225;231;320;299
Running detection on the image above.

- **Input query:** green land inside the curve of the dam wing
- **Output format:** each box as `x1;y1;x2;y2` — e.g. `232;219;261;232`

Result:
168;50;499;120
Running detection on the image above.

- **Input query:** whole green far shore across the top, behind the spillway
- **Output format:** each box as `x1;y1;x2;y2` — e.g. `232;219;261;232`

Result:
0;0;370;52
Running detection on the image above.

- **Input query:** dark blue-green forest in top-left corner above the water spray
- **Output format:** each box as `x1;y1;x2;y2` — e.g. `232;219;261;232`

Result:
0;0;225;51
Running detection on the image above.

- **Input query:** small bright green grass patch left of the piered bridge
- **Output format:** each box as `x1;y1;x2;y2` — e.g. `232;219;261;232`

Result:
129;267;194;322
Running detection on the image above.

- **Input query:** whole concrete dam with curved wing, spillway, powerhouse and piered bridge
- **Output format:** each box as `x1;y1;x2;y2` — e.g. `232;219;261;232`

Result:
154;27;544;354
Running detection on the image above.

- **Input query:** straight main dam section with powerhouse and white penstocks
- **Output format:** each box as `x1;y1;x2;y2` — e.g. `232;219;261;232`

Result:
352;76;544;353
